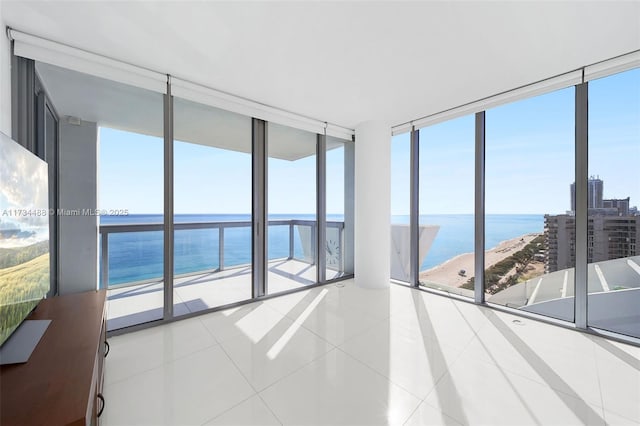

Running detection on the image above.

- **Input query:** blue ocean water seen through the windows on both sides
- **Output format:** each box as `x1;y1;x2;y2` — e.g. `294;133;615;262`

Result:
100;215;544;285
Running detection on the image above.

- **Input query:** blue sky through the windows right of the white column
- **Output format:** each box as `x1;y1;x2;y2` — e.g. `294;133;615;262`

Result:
391;69;640;215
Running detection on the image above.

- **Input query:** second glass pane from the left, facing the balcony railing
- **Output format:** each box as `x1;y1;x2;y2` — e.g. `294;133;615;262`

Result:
173;98;252;316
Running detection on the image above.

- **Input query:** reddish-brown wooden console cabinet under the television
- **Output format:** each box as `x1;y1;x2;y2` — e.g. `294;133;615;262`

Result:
0;290;108;426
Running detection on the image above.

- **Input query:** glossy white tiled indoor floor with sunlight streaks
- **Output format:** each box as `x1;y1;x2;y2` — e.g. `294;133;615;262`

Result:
103;281;640;426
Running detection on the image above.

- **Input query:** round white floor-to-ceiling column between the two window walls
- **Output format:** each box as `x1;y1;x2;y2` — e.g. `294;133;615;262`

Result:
354;121;391;288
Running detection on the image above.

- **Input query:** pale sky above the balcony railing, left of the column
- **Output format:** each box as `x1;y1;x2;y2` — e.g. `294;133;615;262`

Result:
99;128;344;214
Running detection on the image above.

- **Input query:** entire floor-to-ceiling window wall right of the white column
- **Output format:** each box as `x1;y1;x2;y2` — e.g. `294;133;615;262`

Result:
391;64;640;338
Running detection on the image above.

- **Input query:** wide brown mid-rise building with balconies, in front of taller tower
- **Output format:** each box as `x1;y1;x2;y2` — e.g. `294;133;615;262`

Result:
544;214;640;272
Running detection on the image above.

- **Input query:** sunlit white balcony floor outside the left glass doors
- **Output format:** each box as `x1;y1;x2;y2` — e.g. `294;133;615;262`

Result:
107;259;337;330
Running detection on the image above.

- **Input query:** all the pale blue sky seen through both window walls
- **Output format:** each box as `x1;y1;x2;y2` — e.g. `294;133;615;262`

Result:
100;69;640;215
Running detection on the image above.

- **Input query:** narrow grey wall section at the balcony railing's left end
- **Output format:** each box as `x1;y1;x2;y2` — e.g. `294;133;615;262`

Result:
58;118;99;294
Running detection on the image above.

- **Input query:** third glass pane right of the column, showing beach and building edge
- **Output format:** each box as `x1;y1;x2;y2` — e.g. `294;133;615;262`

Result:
484;87;575;321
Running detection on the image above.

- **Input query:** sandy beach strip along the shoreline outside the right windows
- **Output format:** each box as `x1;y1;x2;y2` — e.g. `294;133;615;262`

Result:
420;233;540;287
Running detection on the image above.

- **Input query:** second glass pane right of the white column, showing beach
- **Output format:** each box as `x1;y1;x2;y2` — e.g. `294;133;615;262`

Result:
419;115;475;297
